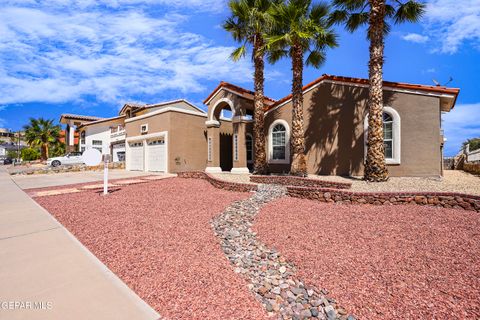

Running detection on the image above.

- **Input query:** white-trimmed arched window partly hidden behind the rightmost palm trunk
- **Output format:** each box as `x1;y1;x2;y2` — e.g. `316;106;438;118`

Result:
364;107;401;164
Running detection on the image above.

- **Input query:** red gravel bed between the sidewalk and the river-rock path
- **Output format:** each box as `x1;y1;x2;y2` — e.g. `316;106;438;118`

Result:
35;178;267;319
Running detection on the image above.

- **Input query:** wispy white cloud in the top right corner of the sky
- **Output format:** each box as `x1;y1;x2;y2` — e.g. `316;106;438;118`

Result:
424;0;480;54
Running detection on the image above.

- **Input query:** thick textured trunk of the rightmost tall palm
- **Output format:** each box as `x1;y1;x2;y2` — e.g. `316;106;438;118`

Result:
364;0;388;181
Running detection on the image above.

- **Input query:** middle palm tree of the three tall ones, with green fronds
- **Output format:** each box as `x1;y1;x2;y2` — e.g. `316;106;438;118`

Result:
266;0;337;176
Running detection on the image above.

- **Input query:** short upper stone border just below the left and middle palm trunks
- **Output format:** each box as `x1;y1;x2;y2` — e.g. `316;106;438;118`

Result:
250;175;352;189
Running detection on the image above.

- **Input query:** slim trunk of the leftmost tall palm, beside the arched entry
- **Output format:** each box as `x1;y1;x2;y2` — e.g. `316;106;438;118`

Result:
252;34;267;174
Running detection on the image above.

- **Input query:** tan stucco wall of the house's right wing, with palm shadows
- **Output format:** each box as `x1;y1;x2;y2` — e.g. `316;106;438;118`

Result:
265;83;441;176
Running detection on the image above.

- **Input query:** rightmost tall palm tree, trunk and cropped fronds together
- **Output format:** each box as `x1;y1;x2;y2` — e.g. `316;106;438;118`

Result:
330;0;425;181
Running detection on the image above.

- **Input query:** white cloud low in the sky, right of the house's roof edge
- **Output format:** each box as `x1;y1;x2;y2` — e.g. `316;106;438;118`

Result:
442;103;480;156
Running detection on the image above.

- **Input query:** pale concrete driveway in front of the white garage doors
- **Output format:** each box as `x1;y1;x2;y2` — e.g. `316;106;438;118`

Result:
11;169;170;189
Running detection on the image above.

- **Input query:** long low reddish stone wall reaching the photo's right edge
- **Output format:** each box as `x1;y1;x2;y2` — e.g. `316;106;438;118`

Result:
287;186;480;212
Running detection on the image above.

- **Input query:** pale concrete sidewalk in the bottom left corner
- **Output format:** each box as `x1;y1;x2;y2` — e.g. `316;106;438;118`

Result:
0;169;160;320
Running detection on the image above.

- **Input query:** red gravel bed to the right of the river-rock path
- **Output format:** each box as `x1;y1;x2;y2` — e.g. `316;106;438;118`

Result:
255;197;480;319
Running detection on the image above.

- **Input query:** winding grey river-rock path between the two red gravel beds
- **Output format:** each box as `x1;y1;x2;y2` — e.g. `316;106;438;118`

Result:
212;184;355;320
